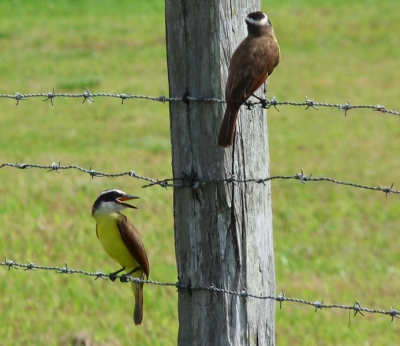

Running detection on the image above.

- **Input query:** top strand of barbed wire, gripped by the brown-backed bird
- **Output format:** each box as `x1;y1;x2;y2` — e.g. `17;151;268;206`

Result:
0;88;400;116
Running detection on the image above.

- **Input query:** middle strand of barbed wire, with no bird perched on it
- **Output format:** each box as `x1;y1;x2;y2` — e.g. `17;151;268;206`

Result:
0;162;400;197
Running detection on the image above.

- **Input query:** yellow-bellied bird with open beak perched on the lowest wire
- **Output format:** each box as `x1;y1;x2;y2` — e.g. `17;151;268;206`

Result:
92;189;150;325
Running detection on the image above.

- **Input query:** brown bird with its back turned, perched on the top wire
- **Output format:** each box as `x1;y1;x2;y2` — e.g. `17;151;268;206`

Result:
218;11;280;148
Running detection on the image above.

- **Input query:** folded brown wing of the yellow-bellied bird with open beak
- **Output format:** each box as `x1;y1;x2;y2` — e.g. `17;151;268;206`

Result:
118;214;150;277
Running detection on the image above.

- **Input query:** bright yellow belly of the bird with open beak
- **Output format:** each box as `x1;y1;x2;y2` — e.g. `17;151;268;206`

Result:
95;214;138;272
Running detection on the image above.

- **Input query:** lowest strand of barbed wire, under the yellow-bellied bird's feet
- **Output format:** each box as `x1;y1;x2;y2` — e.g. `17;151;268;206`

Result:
0;258;400;322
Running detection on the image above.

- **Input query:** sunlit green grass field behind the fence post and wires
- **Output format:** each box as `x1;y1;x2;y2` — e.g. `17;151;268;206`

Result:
0;0;400;345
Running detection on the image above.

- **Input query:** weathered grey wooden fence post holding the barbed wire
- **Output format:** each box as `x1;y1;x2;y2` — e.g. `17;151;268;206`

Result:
166;0;275;346
